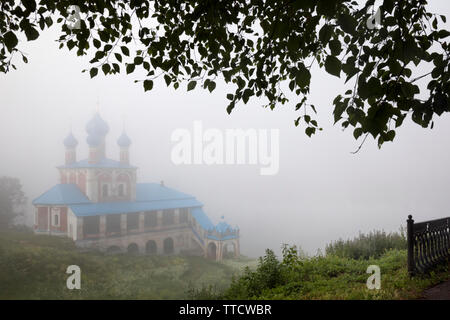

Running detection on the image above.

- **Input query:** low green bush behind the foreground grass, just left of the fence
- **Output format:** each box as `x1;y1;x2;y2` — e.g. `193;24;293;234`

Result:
325;228;406;260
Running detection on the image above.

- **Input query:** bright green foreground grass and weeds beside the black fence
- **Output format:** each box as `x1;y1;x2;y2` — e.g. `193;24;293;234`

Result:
218;247;450;299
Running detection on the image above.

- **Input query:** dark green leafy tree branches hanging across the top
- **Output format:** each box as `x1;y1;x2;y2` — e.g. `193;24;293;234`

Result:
0;0;450;146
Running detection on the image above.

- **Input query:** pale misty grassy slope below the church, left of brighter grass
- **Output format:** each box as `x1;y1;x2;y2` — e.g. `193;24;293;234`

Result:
0;232;254;299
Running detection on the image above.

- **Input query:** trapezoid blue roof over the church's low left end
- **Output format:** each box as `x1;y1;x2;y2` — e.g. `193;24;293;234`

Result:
33;184;91;205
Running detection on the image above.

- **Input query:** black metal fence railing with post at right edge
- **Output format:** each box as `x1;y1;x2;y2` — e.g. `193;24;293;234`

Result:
407;215;450;275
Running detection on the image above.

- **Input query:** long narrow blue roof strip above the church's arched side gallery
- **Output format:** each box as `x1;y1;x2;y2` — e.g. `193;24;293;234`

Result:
69;198;202;217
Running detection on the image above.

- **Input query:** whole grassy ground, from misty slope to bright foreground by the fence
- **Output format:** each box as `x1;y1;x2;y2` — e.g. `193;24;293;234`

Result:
0;231;449;299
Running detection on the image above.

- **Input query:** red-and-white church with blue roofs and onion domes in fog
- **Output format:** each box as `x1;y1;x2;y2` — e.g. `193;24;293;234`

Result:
33;113;240;260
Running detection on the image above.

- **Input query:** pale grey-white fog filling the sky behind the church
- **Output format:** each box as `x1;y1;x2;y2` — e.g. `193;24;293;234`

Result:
0;1;450;257
